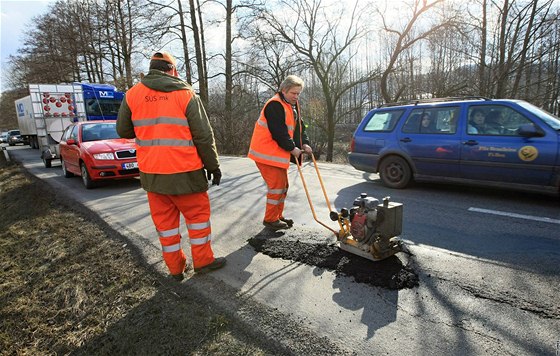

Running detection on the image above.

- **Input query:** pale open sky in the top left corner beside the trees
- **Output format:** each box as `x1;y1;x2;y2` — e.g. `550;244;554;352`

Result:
0;0;54;91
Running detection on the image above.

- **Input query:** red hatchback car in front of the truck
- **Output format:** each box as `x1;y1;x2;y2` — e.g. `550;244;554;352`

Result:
59;121;139;189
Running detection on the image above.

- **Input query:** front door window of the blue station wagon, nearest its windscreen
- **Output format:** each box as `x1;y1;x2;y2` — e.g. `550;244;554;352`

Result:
467;105;533;136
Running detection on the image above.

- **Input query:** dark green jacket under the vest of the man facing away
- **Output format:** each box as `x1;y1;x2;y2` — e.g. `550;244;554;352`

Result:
117;70;220;195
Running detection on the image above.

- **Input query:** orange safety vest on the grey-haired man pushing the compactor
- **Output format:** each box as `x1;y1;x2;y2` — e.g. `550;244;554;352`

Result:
248;94;296;168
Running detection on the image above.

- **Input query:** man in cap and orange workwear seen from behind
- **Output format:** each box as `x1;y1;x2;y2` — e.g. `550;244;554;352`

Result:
117;52;226;281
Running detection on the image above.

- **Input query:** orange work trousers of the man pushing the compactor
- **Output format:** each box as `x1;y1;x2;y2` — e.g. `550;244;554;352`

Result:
255;162;289;222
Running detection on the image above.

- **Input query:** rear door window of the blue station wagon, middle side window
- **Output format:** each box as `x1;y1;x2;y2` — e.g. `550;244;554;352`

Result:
402;107;459;134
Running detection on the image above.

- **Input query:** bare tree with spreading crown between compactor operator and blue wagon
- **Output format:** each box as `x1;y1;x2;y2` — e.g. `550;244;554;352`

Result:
260;0;377;161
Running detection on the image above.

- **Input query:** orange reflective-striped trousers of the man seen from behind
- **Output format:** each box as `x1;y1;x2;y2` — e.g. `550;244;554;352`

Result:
148;192;214;274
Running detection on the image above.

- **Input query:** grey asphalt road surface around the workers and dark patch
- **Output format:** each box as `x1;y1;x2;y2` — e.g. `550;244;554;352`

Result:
8;146;560;355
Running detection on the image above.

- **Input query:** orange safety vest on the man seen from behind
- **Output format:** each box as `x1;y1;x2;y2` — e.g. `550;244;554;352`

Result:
126;83;203;174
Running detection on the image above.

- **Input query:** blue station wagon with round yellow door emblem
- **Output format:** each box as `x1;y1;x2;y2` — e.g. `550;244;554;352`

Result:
348;98;560;195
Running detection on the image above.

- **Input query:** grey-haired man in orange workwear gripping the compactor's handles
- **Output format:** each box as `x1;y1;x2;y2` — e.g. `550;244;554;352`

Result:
248;75;313;230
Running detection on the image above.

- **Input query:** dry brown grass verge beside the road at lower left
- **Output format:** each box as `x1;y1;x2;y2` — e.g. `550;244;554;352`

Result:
0;154;271;355
